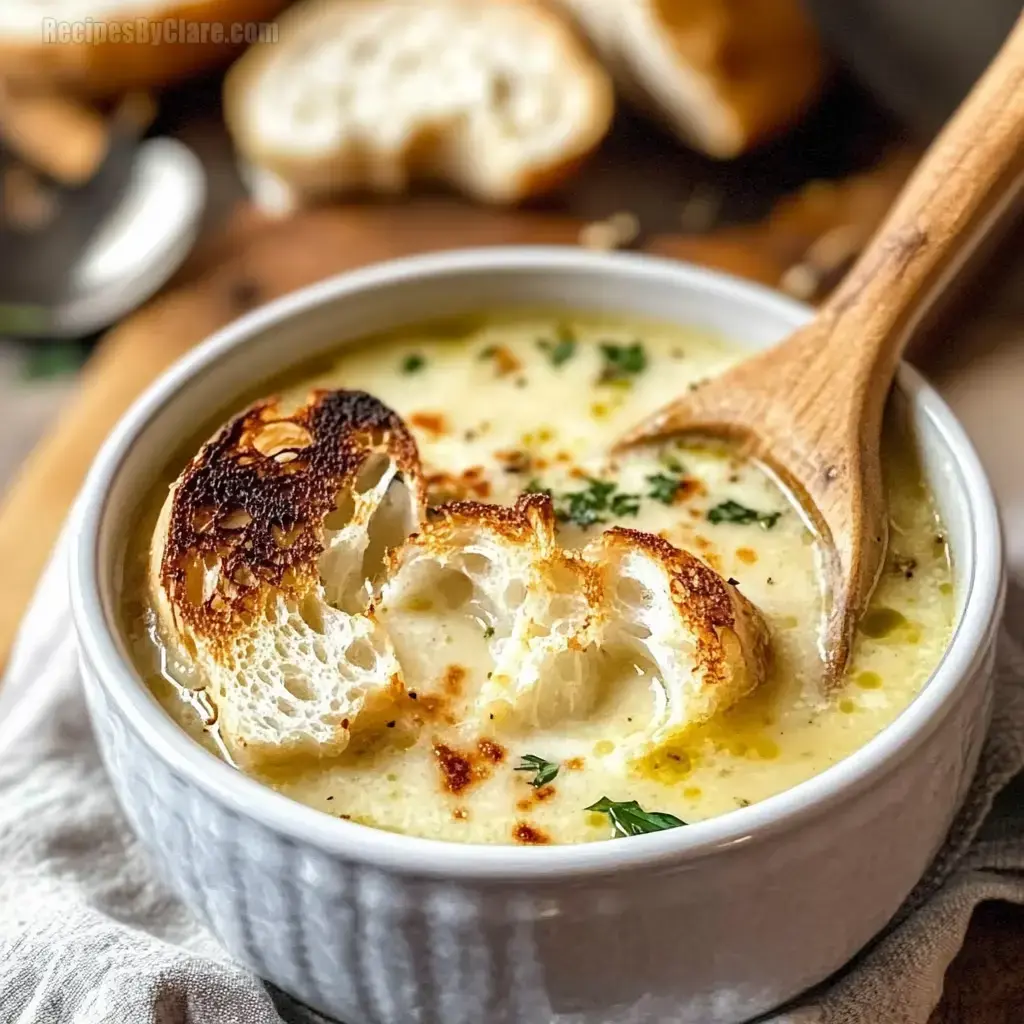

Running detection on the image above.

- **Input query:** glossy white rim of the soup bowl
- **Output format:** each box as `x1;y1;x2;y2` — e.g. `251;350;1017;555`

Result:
69;246;1005;882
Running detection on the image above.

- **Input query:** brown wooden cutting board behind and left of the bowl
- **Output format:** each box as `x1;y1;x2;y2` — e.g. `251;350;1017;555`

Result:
0;202;806;668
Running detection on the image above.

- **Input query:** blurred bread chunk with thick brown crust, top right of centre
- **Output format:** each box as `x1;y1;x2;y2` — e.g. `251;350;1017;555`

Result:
552;0;823;158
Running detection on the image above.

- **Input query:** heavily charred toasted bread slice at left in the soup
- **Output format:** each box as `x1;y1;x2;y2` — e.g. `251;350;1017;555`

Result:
151;391;423;770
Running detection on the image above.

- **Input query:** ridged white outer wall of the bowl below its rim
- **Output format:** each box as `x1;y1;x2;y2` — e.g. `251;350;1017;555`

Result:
84;630;991;1024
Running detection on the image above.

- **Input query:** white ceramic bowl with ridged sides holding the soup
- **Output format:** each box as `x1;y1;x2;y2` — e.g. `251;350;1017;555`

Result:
72;249;1002;1024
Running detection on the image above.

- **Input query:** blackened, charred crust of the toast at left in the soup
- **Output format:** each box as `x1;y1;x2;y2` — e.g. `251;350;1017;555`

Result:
151;390;424;652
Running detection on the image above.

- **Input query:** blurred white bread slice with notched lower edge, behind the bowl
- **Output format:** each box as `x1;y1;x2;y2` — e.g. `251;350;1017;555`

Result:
224;0;612;212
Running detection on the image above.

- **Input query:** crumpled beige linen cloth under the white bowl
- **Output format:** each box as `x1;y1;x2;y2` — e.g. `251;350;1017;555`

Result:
0;549;1024;1024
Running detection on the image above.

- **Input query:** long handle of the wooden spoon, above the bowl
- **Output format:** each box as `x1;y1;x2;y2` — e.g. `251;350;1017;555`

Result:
819;9;1024;378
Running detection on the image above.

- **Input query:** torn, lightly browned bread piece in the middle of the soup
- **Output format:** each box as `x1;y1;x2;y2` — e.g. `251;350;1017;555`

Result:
381;495;770;756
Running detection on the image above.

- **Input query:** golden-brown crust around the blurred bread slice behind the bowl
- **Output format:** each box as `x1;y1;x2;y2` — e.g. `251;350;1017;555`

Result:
223;0;614;204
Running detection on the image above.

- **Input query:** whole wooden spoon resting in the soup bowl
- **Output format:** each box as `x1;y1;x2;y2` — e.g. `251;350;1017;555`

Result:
620;16;1024;683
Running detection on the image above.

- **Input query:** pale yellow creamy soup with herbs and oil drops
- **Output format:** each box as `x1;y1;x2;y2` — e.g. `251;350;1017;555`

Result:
125;313;953;844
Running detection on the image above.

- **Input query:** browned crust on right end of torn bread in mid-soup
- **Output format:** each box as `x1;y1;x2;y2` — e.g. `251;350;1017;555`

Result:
600;526;771;699
